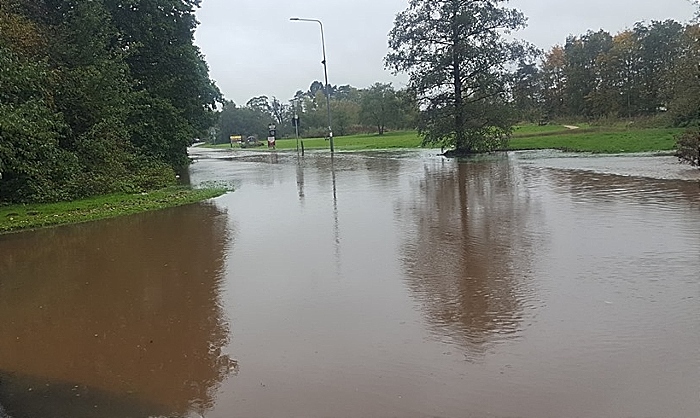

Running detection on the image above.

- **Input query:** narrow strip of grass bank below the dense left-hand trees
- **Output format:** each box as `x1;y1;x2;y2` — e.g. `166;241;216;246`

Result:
0;187;227;234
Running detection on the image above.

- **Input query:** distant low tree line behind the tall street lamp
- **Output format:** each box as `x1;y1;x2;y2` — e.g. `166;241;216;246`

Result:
213;81;418;143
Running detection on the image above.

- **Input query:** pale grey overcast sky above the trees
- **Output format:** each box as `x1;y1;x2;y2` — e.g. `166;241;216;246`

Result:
195;0;694;105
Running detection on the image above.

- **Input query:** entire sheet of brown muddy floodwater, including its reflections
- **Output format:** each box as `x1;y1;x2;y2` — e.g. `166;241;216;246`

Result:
0;150;700;418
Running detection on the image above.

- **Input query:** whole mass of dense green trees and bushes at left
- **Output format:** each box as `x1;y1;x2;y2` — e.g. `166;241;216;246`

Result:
0;0;221;204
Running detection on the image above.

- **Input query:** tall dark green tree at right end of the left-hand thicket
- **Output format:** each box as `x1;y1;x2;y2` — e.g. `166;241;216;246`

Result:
103;0;223;167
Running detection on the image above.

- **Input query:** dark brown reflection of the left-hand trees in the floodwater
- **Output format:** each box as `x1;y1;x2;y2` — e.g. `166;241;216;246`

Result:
0;204;236;418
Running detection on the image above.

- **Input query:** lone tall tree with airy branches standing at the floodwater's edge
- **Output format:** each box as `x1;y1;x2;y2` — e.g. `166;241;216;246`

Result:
386;0;534;153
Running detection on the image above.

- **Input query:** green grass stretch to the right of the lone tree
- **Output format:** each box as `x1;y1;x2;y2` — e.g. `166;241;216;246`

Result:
508;128;682;154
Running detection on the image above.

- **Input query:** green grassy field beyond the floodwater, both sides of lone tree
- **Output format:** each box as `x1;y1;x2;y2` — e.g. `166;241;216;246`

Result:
215;125;682;153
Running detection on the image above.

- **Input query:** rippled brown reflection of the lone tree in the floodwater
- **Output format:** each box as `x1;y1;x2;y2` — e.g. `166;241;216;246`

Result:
401;158;541;358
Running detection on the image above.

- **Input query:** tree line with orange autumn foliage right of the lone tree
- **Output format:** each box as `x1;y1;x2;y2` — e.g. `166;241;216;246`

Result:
513;20;700;126
